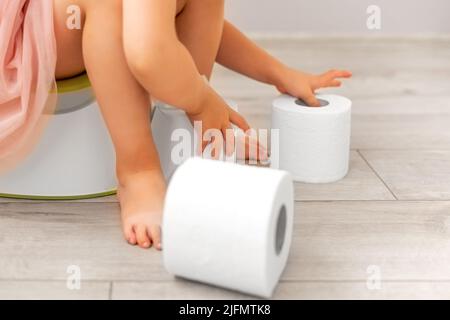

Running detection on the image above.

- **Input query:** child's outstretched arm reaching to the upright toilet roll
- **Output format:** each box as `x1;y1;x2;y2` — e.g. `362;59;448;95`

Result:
217;22;351;106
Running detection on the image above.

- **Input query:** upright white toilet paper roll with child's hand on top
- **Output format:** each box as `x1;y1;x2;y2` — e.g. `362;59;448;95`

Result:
271;95;352;183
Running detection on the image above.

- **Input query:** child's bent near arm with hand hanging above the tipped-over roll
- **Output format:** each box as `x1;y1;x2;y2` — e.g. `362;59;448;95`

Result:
123;0;249;151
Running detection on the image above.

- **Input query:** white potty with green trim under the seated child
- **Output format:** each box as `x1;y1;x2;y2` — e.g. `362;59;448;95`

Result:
0;74;117;200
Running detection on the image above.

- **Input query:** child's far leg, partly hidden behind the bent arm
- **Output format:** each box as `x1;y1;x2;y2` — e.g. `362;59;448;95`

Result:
176;0;224;79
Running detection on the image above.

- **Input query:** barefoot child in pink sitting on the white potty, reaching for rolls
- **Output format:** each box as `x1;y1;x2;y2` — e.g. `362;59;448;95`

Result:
0;0;351;249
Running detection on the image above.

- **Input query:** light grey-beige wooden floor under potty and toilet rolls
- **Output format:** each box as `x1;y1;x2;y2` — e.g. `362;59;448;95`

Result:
0;38;450;299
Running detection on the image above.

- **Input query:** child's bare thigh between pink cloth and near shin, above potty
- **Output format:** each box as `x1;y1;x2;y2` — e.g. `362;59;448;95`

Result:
53;0;86;79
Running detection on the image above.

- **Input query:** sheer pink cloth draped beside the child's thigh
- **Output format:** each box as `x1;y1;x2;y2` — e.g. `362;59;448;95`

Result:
0;0;56;169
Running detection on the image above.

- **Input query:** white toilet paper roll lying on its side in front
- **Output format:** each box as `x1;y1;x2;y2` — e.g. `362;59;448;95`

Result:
162;158;294;297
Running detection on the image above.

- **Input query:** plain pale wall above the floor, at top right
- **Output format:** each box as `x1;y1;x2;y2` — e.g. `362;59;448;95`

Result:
226;0;450;34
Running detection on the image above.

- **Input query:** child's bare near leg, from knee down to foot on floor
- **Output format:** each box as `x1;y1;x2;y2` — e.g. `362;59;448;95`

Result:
73;0;166;248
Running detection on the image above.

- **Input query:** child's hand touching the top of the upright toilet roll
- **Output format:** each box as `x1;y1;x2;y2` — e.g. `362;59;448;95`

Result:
277;69;352;107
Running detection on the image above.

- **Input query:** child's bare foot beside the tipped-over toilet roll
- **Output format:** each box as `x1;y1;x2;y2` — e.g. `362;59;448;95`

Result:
117;170;166;250
